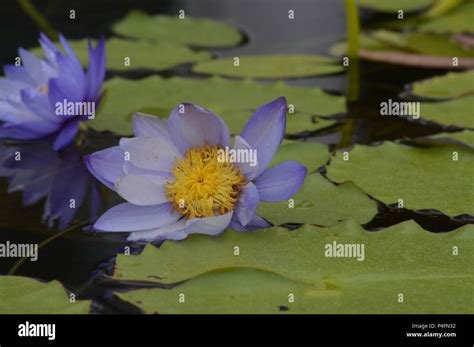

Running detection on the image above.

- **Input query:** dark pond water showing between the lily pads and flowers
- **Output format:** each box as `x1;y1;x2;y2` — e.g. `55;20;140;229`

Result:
0;0;473;313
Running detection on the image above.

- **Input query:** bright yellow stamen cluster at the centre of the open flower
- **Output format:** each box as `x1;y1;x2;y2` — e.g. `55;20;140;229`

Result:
165;145;246;219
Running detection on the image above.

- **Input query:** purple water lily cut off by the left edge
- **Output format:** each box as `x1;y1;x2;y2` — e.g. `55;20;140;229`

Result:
0;34;105;150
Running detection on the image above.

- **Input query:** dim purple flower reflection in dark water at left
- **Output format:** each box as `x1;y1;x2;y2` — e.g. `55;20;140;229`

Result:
0;141;103;230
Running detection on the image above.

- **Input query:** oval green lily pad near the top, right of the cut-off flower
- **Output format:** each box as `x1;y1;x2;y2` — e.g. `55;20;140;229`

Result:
112;11;242;47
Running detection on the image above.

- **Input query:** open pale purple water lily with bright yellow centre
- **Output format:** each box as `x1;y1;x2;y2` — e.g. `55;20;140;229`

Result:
85;97;307;241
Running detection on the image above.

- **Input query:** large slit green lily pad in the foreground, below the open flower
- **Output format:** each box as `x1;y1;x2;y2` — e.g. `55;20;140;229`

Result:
115;221;474;313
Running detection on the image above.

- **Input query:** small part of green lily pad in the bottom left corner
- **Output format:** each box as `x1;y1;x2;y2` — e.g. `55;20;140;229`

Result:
0;276;91;314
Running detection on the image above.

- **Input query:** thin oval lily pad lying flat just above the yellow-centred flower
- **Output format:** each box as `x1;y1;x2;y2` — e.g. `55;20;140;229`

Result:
193;54;344;78
